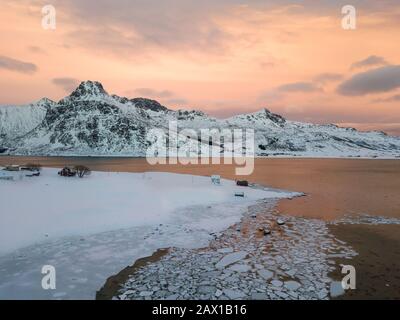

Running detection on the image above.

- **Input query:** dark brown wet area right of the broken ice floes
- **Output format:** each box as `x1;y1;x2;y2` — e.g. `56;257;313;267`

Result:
330;224;400;300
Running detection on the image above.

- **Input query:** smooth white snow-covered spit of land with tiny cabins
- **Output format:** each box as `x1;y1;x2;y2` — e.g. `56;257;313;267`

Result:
0;168;298;299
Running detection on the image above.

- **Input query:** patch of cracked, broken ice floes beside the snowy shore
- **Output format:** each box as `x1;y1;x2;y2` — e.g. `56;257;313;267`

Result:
116;203;357;300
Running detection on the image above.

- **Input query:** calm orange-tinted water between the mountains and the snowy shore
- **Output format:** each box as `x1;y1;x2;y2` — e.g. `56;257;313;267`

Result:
0;156;400;220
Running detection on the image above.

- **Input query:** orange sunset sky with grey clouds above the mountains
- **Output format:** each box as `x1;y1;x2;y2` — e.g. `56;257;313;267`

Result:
0;0;400;135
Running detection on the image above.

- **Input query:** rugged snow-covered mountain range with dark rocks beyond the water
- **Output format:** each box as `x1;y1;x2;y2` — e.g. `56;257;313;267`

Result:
0;81;400;157
